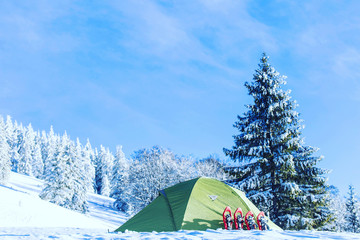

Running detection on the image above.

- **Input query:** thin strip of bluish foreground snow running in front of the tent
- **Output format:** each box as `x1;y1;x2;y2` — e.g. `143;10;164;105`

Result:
0;228;360;240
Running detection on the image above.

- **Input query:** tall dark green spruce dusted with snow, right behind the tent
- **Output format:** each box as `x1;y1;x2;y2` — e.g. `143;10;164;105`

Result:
224;54;328;229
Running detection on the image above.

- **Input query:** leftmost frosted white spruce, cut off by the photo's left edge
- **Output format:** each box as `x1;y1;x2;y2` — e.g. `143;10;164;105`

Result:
0;116;11;184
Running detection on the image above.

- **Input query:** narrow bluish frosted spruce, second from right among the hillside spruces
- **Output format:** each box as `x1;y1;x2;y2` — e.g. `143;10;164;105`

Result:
95;146;114;196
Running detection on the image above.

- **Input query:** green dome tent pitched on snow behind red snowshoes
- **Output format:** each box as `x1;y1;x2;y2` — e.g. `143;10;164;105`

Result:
115;177;281;232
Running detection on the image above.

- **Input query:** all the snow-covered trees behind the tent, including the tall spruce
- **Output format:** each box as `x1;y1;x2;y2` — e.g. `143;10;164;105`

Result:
0;54;360;233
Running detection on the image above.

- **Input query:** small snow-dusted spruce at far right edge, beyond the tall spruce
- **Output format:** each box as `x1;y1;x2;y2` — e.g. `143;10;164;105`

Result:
345;185;360;233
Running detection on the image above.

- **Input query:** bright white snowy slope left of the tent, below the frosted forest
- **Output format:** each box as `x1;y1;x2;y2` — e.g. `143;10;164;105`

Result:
0;173;126;230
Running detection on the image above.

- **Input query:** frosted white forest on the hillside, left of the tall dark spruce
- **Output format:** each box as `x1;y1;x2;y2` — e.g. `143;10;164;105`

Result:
0;116;227;215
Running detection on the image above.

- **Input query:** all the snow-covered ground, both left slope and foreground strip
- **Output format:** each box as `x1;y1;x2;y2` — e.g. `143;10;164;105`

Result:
0;173;360;240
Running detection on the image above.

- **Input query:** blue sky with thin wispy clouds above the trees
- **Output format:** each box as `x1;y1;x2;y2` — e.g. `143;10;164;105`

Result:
0;0;360;193
